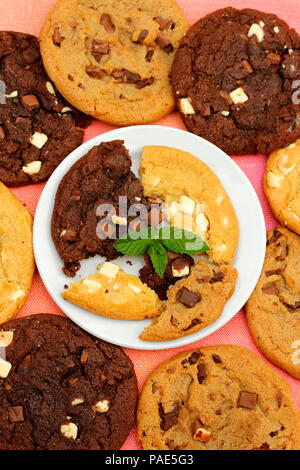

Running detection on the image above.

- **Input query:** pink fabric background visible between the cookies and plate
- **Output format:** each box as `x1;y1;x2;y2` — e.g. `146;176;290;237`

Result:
0;0;300;450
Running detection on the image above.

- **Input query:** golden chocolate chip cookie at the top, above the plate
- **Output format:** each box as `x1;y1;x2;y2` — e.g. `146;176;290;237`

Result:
40;0;189;126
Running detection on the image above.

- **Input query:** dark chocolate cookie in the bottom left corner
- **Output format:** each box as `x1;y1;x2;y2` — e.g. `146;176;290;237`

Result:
0;315;137;450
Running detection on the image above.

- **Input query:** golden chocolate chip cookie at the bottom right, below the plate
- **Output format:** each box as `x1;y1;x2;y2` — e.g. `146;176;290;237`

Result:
138;346;300;451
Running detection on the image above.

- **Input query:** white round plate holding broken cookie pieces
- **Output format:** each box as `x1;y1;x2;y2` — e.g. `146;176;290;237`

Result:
33;125;266;350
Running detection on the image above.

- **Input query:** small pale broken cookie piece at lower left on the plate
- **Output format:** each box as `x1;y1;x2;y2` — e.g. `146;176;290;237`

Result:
62;262;164;320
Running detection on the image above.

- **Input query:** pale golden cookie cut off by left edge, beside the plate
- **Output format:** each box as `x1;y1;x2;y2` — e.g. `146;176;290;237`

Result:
0;183;35;324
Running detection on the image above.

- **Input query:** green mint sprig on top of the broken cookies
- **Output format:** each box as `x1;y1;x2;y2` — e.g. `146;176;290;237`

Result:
114;226;209;277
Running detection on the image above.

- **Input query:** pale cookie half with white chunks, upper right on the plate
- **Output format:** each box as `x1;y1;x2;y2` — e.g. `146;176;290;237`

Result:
140;146;239;264
